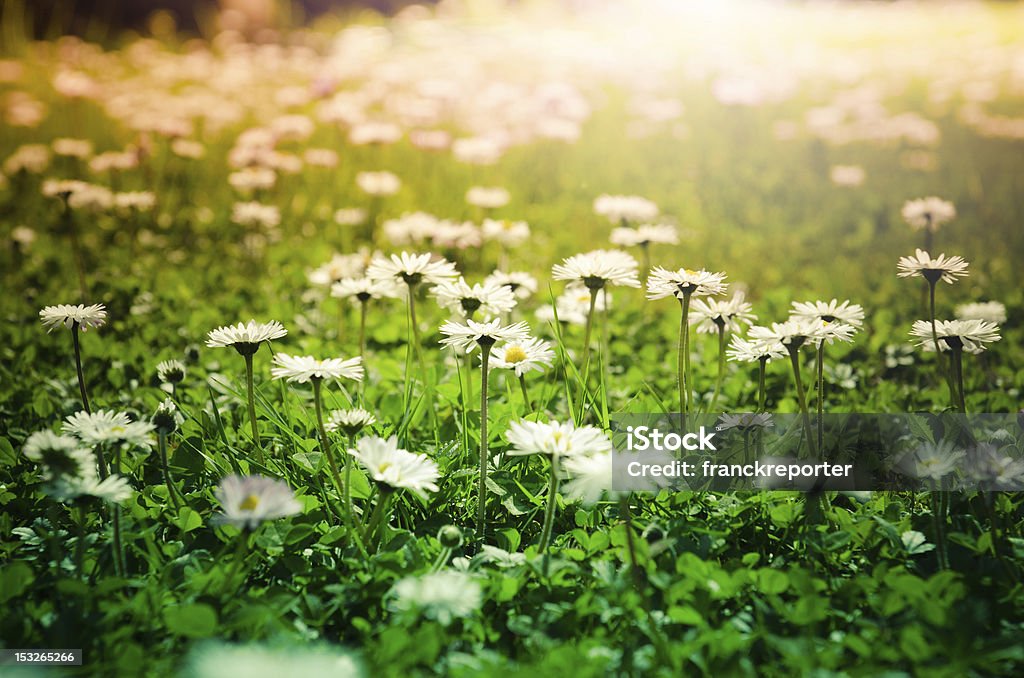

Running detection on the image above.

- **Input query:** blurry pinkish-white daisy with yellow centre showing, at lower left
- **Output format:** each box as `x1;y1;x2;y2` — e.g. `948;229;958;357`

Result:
214;475;302;529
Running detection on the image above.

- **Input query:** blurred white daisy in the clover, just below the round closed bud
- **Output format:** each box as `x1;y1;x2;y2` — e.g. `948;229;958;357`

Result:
388;569;483;626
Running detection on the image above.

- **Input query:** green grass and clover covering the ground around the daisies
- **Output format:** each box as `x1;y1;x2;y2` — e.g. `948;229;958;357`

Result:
0;2;1024;676
